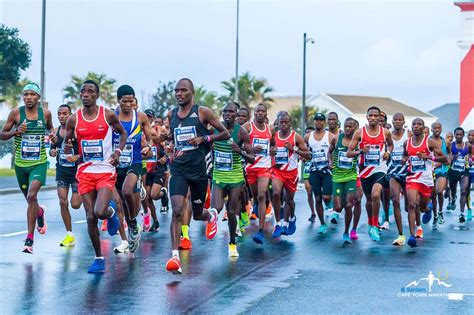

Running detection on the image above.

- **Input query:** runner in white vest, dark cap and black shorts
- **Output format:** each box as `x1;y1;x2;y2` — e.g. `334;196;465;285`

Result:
304;113;337;234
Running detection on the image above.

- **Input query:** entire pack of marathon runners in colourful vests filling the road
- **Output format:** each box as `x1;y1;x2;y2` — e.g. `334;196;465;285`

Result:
0;78;474;273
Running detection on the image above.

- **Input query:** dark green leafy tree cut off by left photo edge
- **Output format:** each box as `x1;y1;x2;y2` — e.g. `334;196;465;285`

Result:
0;24;31;99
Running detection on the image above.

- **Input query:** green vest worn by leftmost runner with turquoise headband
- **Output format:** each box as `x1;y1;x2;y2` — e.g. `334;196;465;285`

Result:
15;106;48;167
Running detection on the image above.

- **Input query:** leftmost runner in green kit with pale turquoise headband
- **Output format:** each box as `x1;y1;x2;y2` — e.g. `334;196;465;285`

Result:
0;83;55;254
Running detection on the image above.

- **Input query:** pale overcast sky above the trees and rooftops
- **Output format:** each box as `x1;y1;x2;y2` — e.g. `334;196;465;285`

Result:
0;0;461;122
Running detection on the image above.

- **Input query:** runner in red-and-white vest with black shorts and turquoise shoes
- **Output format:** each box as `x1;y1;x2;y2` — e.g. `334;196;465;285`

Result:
347;106;393;241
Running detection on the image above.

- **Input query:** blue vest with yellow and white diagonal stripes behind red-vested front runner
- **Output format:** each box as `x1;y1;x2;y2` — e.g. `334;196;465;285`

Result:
113;110;142;168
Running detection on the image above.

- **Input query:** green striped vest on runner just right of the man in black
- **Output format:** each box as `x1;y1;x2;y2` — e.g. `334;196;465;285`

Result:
212;124;244;184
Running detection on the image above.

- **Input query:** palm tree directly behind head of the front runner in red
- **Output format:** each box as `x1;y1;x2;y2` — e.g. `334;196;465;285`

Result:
63;72;117;109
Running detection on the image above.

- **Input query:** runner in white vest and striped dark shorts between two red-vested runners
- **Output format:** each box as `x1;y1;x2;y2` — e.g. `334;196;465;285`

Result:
381;113;411;246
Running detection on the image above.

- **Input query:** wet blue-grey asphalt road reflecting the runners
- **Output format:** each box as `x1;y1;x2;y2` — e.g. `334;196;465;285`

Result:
0;191;474;314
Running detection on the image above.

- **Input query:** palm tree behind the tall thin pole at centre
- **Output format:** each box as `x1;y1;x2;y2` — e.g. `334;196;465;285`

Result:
221;72;274;110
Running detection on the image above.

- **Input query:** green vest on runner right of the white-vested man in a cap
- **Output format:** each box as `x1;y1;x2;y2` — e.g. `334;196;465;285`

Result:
332;133;357;183
